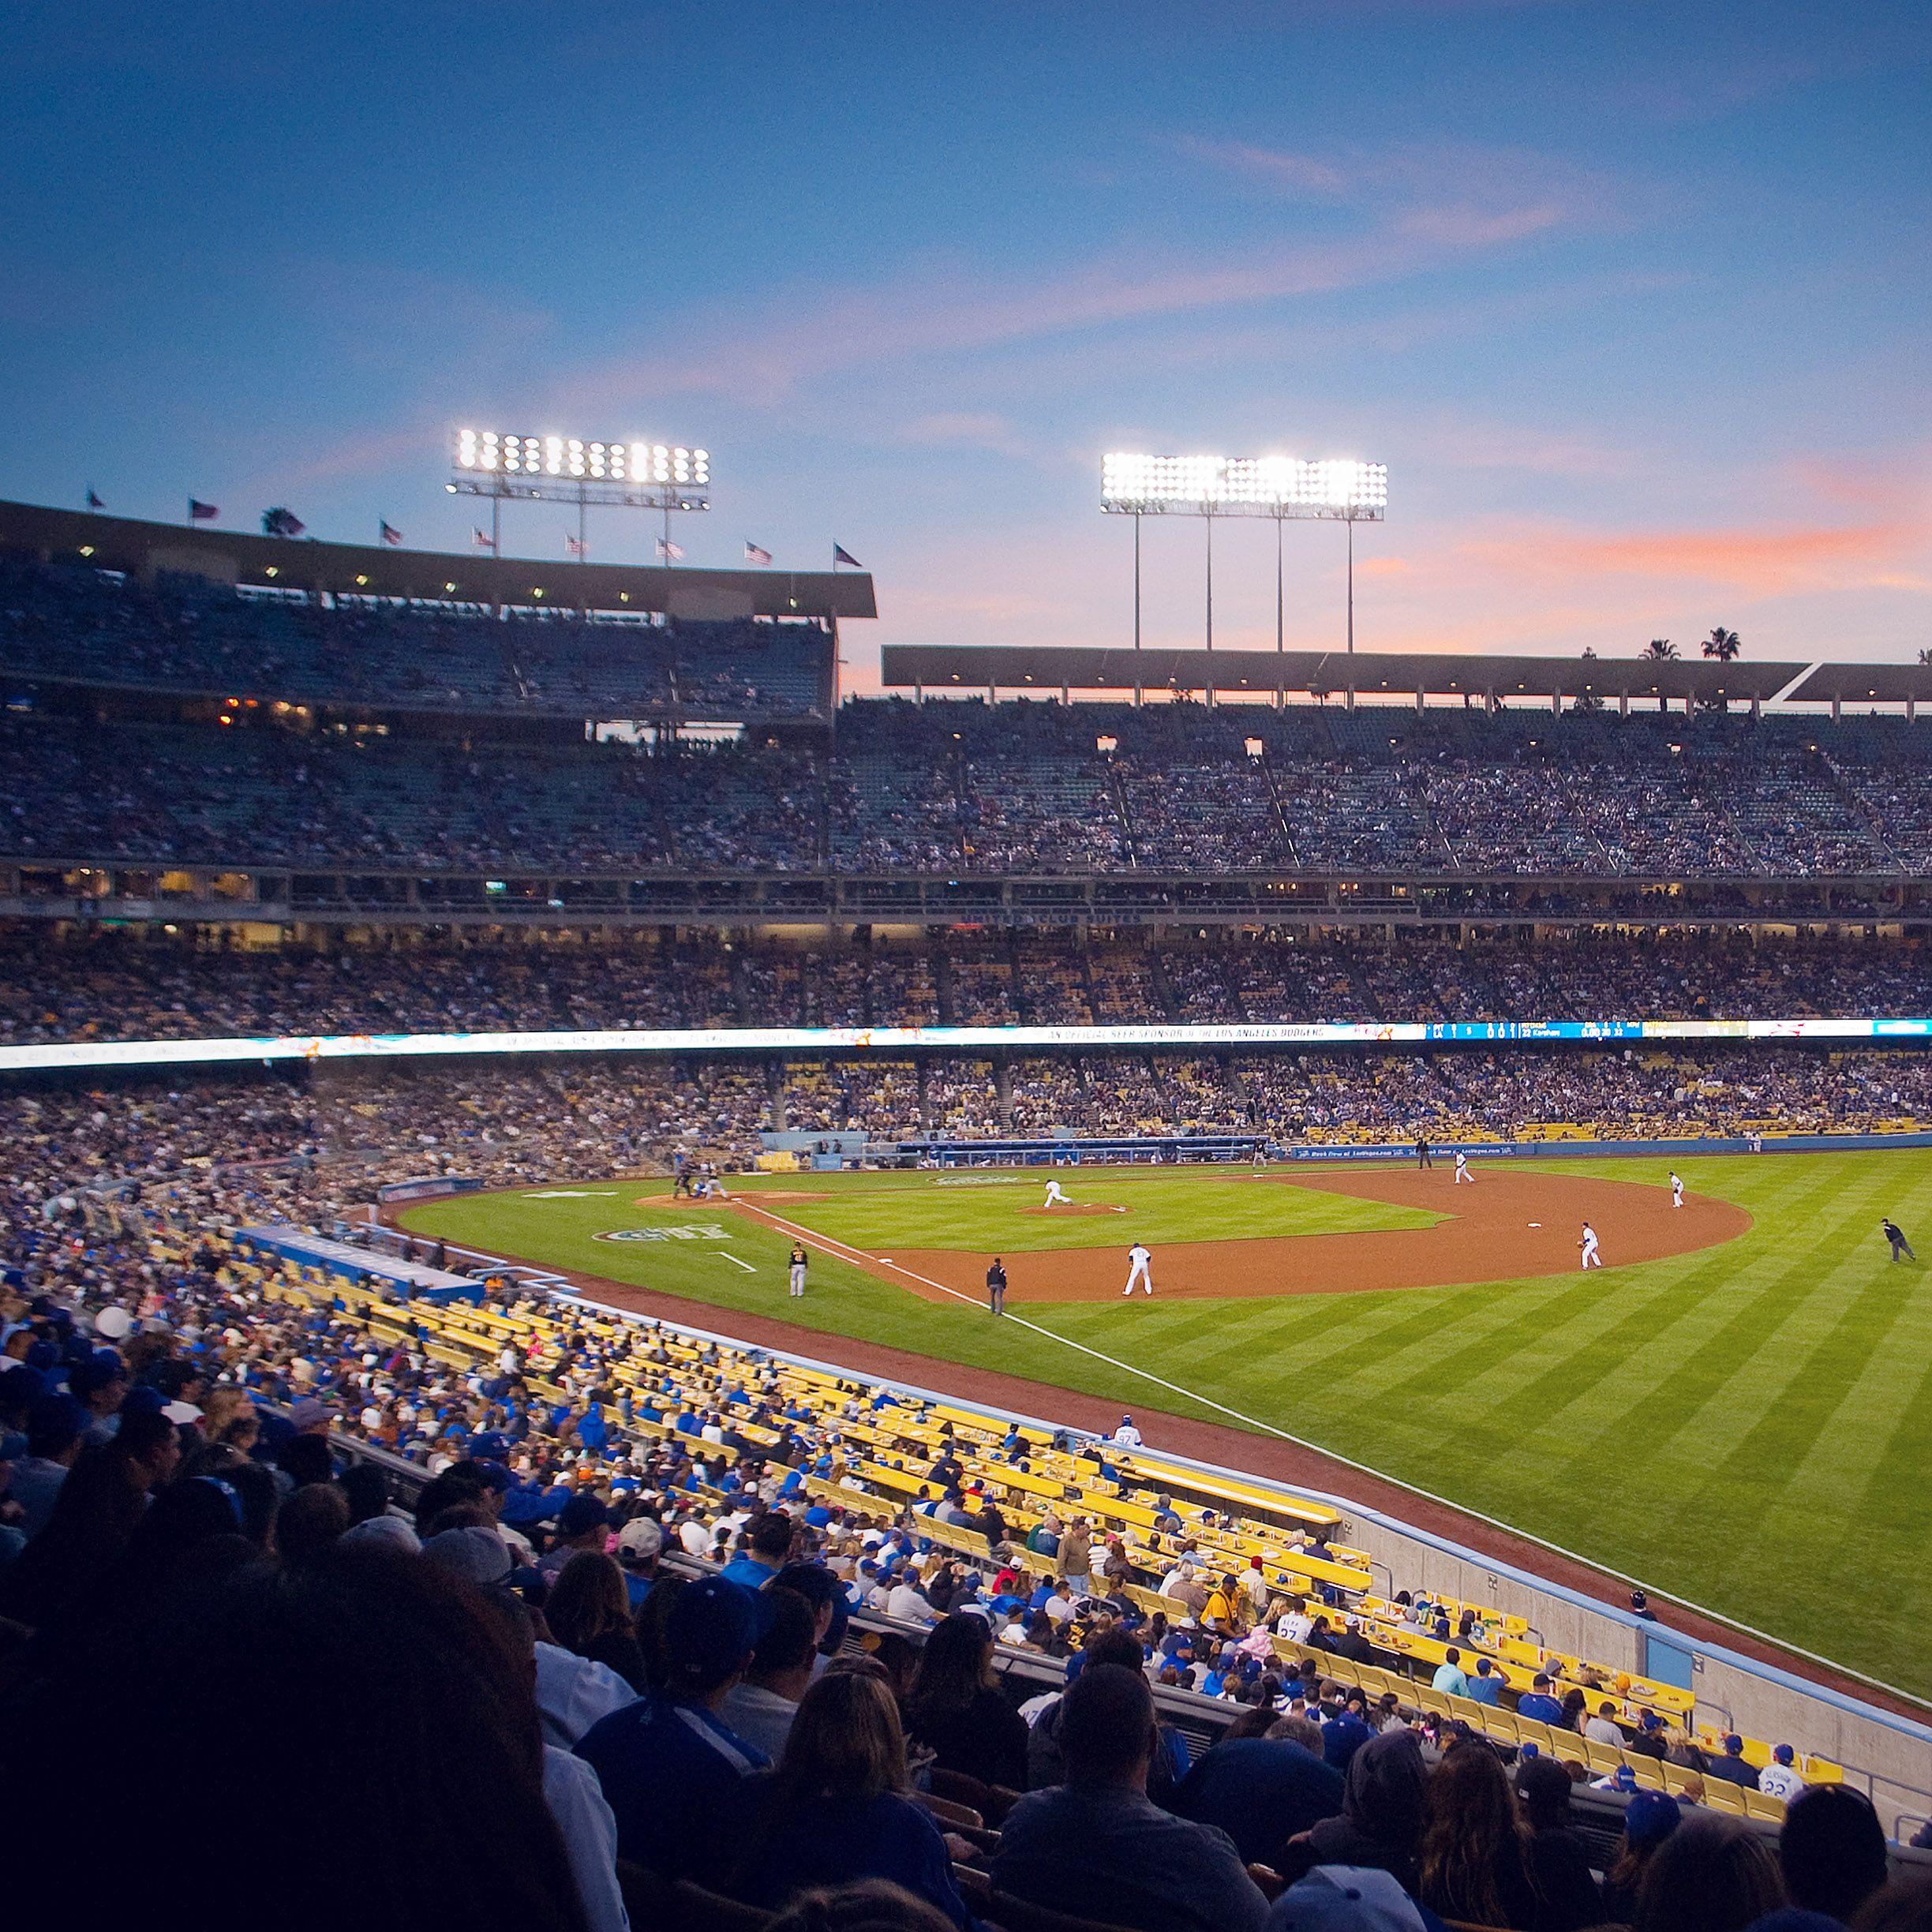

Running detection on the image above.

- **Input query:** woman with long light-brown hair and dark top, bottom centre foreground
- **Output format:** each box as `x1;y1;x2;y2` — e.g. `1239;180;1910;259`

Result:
730;1672;974;1932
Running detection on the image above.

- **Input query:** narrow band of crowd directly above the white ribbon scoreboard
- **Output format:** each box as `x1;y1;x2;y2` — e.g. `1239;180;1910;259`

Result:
0;923;1932;1043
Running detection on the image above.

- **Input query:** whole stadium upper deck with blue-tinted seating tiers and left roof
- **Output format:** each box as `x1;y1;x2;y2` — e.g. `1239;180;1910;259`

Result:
0;506;1932;926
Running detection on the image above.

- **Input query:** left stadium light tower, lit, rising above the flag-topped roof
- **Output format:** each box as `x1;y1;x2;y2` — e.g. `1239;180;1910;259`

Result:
444;429;711;564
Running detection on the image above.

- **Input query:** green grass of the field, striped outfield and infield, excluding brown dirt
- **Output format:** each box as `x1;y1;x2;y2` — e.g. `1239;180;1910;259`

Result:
406;1150;1932;1696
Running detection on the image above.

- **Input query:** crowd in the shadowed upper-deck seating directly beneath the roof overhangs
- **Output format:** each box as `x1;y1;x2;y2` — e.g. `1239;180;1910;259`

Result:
18;564;1932;881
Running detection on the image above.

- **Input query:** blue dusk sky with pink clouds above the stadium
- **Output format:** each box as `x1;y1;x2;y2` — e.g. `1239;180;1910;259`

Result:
0;0;1932;684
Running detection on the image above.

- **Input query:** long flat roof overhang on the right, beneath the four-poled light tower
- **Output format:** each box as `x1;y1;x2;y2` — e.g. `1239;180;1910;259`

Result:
881;643;1808;703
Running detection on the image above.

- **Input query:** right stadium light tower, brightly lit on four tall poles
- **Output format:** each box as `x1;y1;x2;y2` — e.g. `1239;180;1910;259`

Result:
1099;452;1389;653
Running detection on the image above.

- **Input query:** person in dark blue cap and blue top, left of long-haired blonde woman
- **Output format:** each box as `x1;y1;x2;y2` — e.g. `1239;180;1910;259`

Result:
578;1577;771;1885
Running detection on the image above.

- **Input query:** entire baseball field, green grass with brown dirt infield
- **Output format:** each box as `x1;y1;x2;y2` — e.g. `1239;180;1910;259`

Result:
402;1151;1932;1696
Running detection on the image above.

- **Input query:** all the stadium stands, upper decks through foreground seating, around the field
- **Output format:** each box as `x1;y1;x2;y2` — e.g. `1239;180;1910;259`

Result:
0;504;1932;1932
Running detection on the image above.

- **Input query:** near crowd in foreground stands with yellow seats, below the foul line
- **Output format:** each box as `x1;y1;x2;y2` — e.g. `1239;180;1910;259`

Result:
0;1094;1932;1932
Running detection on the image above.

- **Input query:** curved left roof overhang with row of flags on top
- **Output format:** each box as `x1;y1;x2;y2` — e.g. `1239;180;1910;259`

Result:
0;502;879;618
